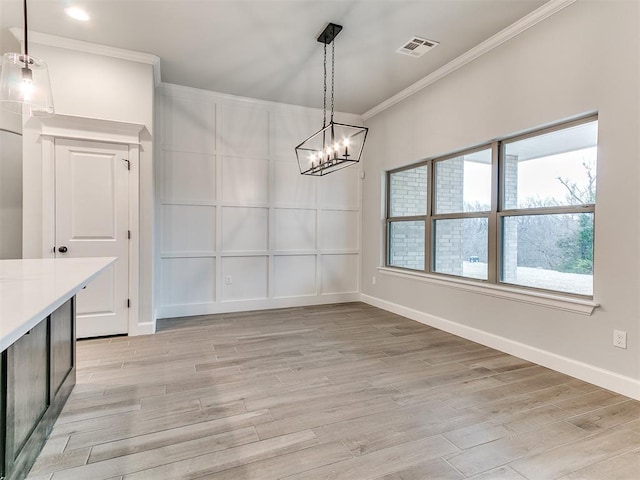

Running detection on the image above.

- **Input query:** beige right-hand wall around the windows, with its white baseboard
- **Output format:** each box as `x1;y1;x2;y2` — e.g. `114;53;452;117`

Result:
362;0;640;398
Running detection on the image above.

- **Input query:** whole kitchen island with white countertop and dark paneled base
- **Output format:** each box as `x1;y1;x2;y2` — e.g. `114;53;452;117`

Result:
0;258;116;480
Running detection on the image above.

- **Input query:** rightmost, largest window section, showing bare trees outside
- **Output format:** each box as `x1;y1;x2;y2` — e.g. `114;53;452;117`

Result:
499;120;598;295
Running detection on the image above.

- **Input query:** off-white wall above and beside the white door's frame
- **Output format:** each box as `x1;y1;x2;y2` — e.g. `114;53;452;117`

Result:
23;41;155;333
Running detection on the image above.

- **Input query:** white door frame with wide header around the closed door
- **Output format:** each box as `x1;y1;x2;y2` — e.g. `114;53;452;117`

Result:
40;115;144;335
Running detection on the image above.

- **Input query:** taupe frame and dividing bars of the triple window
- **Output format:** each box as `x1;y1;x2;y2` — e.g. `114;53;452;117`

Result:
384;113;598;300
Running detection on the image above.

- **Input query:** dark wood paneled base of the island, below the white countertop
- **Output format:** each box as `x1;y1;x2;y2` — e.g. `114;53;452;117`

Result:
0;298;75;480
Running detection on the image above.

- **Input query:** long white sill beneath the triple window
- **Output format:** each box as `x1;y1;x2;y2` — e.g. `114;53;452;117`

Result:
378;267;600;315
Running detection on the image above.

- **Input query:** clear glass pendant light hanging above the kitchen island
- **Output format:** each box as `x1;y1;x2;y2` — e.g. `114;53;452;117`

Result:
0;0;55;117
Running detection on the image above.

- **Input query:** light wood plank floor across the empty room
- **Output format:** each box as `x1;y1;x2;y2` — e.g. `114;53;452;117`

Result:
29;303;640;480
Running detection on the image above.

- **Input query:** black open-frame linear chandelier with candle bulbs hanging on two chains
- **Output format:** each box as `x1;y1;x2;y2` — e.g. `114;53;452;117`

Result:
296;23;368;176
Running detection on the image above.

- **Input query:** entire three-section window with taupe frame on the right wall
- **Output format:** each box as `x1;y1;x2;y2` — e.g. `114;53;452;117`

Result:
386;116;598;296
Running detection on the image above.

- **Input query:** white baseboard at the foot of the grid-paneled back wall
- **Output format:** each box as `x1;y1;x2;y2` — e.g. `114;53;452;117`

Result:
157;292;360;319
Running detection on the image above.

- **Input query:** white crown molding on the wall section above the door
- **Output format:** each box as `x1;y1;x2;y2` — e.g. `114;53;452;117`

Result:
9;27;162;86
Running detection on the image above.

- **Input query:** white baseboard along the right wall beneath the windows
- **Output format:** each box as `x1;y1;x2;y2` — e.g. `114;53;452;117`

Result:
361;294;640;400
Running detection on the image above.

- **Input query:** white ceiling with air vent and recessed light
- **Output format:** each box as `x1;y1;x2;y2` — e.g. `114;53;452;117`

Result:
0;0;546;114
